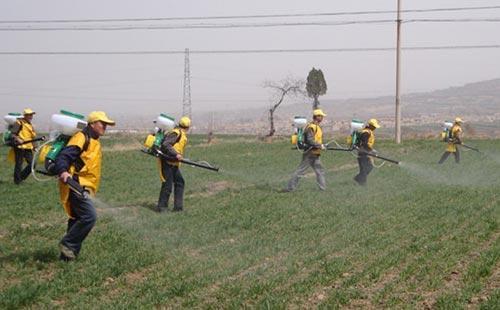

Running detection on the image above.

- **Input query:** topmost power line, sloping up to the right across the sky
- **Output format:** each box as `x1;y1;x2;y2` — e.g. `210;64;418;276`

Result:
0;6;500;24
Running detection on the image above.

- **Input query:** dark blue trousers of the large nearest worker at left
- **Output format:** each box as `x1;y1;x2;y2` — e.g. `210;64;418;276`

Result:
61;191;97;255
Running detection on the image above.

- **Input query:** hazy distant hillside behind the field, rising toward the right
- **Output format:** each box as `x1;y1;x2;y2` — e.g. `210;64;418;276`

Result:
195;79;500;134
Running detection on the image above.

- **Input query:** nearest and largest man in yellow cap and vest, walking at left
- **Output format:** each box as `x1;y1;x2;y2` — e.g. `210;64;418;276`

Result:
55;111;115;261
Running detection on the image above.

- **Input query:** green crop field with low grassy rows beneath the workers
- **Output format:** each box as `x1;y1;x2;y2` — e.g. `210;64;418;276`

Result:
0;136;500;309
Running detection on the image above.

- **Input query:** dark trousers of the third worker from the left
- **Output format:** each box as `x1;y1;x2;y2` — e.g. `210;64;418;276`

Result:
158;160;184;211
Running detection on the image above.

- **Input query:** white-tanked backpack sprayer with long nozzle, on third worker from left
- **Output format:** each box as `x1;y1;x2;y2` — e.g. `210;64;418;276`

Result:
141;114;219;171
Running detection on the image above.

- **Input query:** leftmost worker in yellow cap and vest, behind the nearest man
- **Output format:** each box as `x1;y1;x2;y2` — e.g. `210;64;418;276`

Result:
12;108;36;184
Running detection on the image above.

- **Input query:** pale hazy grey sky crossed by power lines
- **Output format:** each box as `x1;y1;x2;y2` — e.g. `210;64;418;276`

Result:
0;0;500;127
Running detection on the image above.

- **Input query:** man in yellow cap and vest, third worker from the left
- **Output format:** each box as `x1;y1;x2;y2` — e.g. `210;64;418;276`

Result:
156;116;191;212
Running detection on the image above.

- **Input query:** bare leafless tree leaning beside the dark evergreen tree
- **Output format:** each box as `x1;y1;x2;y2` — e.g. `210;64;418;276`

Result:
263;77;305;137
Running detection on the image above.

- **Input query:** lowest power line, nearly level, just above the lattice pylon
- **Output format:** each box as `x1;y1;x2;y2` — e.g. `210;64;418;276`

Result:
0;44;500;56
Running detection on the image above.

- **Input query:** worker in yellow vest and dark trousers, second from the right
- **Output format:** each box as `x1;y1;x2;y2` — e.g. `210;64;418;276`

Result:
354;118;380;185
